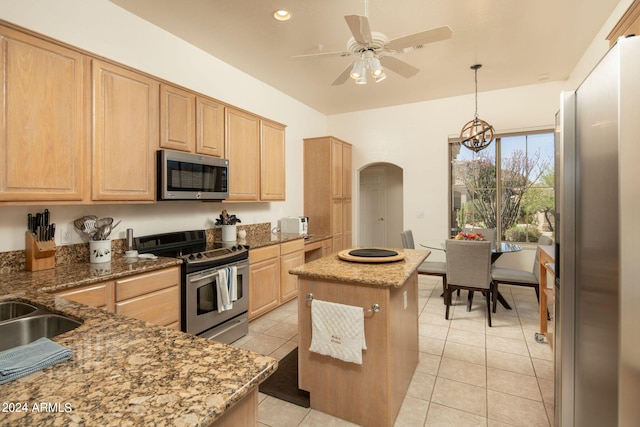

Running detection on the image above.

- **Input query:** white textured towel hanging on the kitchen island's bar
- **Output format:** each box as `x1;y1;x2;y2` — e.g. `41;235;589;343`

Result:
309;299;367;365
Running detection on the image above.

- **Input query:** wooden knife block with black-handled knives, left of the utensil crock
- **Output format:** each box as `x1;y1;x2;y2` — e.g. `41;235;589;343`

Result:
25;209;56;271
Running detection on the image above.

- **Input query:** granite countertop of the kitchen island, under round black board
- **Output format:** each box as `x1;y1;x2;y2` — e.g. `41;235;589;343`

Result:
289;249;431;287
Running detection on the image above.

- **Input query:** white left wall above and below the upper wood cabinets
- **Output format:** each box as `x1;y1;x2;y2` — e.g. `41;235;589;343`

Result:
0;0;327;252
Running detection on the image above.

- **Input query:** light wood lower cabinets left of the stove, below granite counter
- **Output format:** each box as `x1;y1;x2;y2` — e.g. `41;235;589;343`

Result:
55;267;180;330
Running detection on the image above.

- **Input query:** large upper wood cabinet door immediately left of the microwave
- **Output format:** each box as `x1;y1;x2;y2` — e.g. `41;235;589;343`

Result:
92;60;159;201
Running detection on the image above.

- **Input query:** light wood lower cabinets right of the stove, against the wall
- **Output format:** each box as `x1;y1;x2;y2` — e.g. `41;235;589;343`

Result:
249;239;304;320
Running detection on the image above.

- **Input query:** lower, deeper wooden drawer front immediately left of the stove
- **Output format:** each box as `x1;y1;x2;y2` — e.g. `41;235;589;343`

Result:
116;286;180;326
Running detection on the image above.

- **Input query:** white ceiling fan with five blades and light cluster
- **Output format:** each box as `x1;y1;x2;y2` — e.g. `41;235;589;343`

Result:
294;15;452;86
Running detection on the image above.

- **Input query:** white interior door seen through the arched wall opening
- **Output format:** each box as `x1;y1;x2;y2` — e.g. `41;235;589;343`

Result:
358;166;387;247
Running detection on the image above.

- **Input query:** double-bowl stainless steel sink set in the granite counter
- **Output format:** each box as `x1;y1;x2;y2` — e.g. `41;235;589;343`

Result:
0;301;82;351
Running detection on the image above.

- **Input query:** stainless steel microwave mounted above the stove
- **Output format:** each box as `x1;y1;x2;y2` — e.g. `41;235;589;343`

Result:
158;150;229;200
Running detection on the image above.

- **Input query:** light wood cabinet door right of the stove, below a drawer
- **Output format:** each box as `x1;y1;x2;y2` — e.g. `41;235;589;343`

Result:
249;258;280;320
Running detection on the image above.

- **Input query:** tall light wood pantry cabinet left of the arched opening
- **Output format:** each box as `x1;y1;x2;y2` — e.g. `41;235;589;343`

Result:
304;136;352;252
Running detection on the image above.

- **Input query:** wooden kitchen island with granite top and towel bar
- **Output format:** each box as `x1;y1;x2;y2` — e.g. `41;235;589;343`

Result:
290;249;430;426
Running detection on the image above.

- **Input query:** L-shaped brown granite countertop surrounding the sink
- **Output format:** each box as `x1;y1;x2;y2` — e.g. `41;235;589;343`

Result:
0;257;278;426
